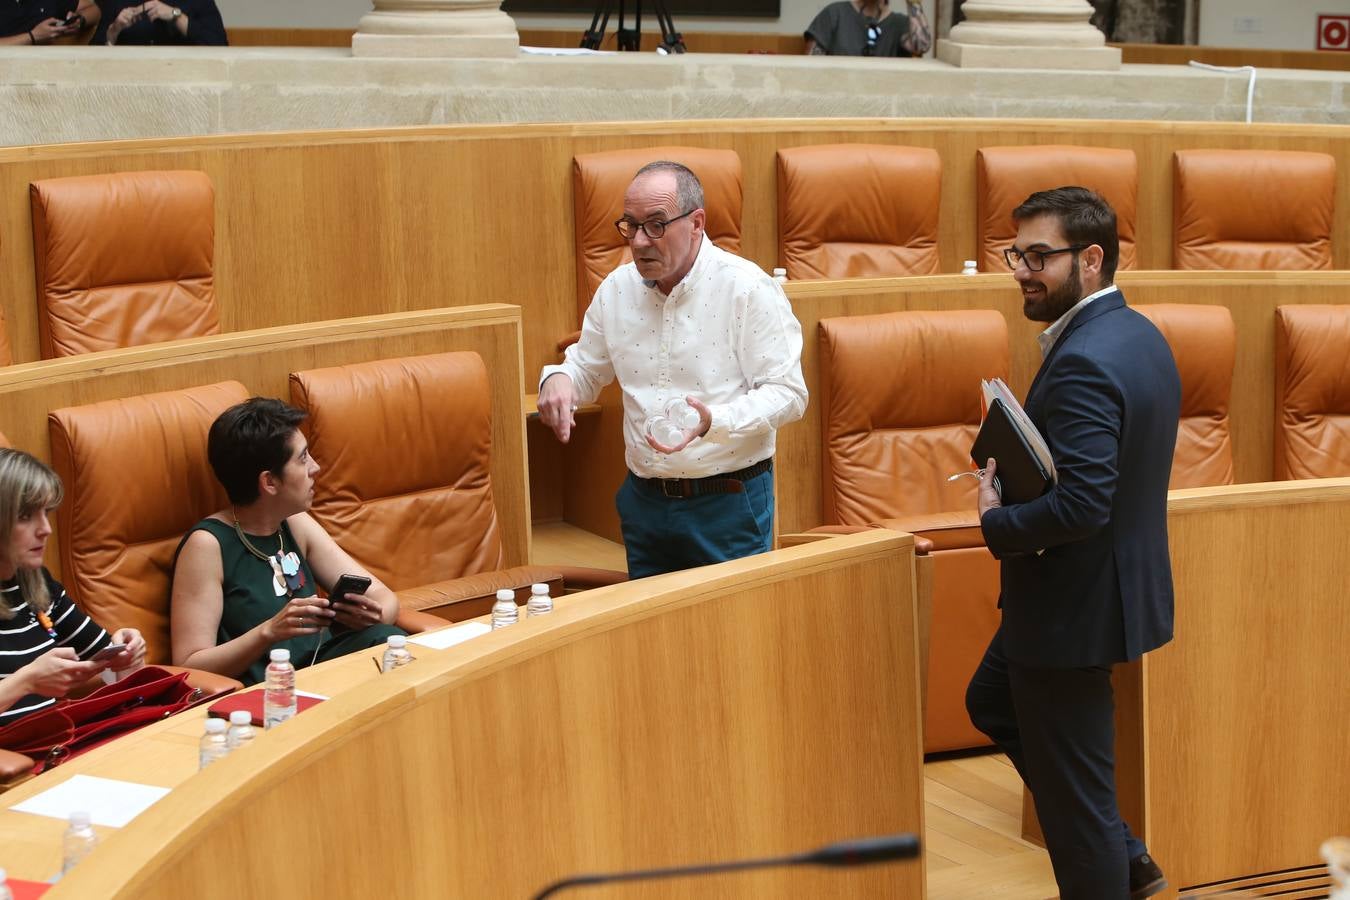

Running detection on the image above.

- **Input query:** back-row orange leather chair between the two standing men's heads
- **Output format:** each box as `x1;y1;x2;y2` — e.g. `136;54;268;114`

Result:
778;144;942;281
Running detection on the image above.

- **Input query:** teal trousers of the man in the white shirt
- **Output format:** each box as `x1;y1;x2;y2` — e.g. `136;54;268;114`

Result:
614;471;774;579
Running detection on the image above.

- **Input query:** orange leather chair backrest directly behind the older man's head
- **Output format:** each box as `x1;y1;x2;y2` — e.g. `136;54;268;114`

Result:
572;147;743;324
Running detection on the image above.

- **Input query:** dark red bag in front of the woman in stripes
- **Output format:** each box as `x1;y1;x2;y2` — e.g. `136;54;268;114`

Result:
0;665;219;775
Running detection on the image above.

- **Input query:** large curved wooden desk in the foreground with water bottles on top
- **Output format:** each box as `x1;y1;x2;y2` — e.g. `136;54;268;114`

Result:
0;532;923;900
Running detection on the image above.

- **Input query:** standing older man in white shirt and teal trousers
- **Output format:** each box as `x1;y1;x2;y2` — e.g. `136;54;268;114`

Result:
539;162;806;578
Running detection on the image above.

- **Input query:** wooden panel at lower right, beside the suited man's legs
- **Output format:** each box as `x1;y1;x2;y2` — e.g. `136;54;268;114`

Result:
1141;479;1350;888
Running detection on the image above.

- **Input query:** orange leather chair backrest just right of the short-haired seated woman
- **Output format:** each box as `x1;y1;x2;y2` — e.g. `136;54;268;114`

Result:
290;352;505;591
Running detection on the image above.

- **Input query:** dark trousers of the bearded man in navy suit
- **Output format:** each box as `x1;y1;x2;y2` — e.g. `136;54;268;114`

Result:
965;629;1146;900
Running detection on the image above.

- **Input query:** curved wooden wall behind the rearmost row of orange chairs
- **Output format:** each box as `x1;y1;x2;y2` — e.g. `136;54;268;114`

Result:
0;119;1350;374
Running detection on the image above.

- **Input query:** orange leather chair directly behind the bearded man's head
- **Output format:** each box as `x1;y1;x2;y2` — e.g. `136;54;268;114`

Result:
975;144;1139;271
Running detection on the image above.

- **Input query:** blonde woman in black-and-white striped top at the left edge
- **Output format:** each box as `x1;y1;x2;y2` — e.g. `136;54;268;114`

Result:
0;448;146;726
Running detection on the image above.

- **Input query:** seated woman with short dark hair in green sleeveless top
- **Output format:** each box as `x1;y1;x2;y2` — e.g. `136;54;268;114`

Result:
170;397;404;684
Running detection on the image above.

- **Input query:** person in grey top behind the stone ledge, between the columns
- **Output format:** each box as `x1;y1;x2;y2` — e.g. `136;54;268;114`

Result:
802;0;933;57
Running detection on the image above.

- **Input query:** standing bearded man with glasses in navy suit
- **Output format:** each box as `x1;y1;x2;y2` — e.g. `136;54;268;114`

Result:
965;188;1181;900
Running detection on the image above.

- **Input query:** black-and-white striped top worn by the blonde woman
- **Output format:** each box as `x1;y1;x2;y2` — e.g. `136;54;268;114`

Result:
0;568;112;726
